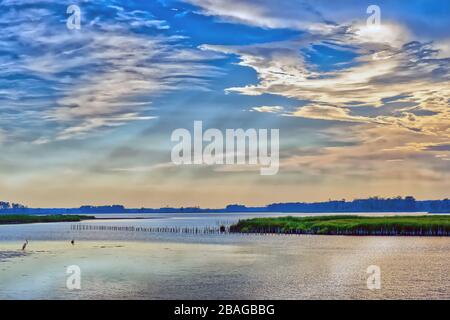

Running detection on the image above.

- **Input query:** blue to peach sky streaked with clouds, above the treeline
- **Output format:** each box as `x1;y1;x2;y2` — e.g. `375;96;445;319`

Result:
0;0;450;207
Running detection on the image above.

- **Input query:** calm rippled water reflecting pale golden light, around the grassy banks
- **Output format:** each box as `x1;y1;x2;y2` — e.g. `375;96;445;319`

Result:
0;214;450;299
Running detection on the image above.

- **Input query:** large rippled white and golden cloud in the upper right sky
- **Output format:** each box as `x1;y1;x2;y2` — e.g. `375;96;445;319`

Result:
204;27;450;136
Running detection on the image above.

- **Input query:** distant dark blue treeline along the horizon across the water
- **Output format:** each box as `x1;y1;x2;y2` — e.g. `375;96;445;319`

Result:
0;196;450;214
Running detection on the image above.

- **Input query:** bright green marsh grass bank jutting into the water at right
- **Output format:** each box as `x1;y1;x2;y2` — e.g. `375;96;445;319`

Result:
230;215;450;236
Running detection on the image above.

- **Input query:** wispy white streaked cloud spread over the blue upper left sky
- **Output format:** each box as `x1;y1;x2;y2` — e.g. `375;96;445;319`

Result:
0;1;221;141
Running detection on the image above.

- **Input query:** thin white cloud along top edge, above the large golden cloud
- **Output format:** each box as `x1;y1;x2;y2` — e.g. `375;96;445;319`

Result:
184;0;450;40
